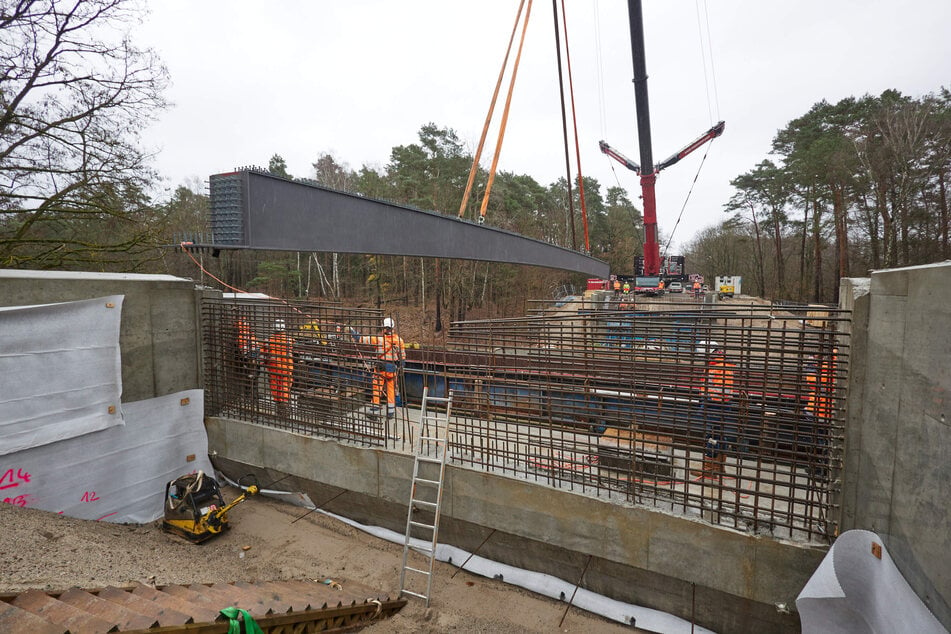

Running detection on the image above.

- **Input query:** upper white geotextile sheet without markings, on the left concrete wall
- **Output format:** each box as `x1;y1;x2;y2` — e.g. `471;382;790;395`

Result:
0;295;123;456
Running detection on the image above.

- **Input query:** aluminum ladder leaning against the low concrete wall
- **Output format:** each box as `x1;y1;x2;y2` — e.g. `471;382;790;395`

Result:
399;387;452;607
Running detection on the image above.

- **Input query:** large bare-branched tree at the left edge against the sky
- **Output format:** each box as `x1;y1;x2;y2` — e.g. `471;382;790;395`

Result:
0;0;168;268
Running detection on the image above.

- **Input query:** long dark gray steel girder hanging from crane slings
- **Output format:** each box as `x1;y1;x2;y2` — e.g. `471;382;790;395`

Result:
207;170;609;278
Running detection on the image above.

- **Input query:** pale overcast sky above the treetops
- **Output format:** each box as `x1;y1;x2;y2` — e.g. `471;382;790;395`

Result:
134;0;951;253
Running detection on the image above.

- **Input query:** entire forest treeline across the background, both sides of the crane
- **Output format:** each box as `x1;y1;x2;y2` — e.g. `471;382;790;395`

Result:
0;0;951;320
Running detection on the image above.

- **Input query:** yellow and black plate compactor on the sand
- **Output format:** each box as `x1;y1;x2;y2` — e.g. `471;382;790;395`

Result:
162;471;258;544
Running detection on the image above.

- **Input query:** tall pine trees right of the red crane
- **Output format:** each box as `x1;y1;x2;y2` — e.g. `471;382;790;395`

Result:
690;87;951;302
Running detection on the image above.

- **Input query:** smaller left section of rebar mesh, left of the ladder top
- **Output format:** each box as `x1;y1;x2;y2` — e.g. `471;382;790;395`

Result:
202;299;387;446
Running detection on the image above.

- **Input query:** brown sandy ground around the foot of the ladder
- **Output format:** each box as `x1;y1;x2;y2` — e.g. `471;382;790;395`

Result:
0;488;635;634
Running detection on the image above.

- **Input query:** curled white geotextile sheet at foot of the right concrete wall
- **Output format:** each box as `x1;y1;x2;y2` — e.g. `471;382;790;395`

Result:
796;530;947;634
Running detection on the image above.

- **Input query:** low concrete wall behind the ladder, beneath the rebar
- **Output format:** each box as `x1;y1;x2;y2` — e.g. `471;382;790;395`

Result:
206;418;824;632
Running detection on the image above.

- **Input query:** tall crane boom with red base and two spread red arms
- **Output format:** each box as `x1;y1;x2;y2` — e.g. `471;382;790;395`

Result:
599;0;726;276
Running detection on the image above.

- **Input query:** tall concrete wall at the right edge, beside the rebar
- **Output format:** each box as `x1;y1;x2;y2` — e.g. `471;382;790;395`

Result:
841;262;951;629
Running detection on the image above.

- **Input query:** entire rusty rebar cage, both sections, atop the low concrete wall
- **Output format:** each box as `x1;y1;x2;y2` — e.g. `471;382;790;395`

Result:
204;296;850;542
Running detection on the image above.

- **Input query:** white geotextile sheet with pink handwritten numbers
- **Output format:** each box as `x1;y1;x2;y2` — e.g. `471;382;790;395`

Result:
0;390;214;524
